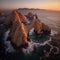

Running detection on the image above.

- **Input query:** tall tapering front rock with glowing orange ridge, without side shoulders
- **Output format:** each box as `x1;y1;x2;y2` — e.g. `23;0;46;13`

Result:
10;11;28;47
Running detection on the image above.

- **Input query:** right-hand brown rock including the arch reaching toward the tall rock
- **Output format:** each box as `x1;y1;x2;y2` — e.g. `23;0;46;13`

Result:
26;19;51;35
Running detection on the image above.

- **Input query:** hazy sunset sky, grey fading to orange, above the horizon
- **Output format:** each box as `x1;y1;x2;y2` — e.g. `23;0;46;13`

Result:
0;0;60;11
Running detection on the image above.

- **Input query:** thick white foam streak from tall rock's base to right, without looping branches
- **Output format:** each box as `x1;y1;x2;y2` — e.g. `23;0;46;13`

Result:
23;38;51;54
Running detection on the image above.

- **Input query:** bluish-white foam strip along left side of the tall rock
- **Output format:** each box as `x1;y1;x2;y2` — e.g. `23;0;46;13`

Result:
3;30;15;53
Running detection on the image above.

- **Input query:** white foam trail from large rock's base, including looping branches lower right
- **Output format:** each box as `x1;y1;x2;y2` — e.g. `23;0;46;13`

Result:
23;37;60;57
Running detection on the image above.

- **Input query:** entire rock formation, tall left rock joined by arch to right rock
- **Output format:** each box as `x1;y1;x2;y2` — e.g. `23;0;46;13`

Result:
0;10;51;47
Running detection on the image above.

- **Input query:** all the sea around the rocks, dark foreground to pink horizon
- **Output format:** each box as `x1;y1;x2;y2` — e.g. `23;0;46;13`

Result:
0;10;60;60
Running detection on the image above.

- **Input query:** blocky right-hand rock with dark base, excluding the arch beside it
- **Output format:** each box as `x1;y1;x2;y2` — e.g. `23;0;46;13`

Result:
34;19;51;35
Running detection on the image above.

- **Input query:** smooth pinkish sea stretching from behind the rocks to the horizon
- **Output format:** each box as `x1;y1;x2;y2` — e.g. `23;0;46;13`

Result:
19;10;60;32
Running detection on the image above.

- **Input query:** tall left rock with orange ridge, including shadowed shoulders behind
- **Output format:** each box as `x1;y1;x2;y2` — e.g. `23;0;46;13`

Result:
0;11;29;47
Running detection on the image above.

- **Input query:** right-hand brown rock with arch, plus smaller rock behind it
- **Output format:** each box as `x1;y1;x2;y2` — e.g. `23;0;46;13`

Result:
27;12;51;35
